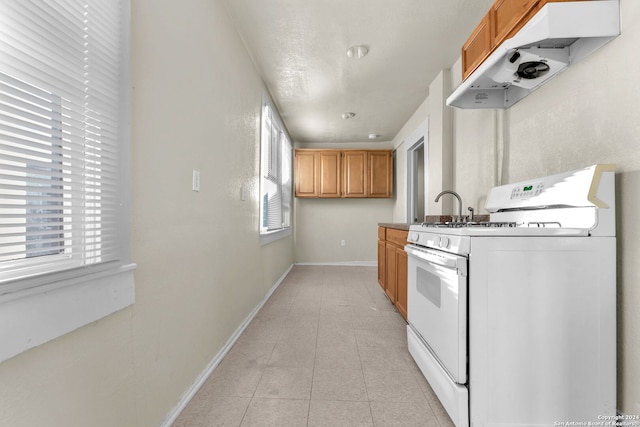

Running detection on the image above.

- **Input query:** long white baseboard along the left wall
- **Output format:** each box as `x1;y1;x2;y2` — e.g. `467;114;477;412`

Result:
160;264;293;427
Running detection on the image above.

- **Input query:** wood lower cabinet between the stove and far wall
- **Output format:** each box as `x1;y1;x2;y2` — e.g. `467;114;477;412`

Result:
378;227;408;320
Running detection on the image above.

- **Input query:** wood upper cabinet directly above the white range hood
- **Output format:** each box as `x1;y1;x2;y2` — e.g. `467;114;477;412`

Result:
462;0;580;80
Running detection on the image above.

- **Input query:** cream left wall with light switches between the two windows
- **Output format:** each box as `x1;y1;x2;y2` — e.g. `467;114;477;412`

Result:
0;0;293;426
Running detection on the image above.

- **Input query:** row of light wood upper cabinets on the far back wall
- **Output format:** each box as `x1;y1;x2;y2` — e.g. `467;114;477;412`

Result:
295;149;393;198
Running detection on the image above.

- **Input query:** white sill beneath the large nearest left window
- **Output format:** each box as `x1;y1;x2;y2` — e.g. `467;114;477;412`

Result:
0;264;136;362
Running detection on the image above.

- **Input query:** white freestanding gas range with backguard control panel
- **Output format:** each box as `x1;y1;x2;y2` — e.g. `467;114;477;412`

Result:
405;165;616;427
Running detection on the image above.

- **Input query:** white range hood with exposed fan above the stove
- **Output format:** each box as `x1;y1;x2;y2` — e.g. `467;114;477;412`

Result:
447;0;620;109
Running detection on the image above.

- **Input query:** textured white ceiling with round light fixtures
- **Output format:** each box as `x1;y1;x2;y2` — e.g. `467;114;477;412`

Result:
225;0;493;143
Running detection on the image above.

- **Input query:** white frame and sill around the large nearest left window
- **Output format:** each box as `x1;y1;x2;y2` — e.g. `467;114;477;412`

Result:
0;0;136;363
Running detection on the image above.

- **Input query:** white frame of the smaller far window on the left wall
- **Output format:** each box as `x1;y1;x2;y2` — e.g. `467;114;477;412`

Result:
258;94;293;245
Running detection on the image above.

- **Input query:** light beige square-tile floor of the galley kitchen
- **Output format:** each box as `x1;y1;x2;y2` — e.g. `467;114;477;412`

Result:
173;266;453;427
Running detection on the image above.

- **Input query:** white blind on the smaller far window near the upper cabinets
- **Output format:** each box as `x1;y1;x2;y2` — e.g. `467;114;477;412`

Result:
260;103;292;234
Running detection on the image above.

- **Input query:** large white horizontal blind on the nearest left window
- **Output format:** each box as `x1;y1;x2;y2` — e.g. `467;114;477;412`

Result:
0;0;123;285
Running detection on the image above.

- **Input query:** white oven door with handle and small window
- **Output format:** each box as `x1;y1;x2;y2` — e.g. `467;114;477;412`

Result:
405;245;467;384
